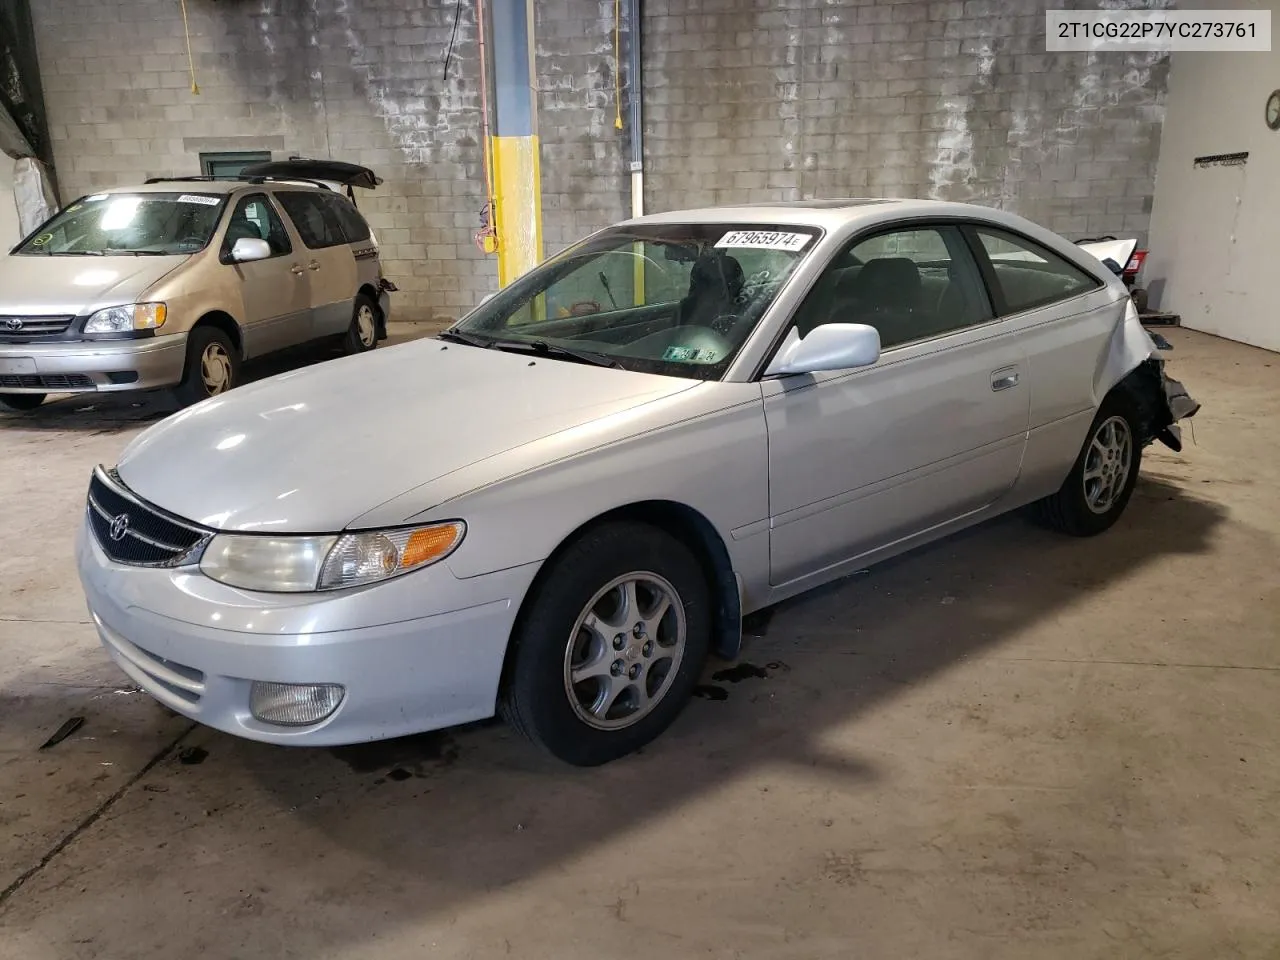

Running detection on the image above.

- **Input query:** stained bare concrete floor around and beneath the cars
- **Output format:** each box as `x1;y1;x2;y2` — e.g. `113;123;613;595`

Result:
0;330;1280;960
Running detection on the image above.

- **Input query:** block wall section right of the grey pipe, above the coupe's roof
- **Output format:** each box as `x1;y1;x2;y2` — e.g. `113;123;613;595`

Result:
644;0;1167;248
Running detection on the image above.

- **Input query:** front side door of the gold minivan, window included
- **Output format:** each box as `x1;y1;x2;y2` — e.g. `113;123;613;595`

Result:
220;193;311;357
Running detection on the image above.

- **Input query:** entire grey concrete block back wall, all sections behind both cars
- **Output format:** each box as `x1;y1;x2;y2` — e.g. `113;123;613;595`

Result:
32;0;1166;320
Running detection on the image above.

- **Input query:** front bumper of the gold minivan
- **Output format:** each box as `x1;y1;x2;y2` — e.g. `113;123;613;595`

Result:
0;333;187;393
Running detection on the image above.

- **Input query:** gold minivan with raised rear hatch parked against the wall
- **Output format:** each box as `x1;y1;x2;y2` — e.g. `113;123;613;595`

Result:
0;160;396;411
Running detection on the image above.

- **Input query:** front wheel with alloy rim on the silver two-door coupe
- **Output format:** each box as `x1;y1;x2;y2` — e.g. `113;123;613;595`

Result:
499;522;712;767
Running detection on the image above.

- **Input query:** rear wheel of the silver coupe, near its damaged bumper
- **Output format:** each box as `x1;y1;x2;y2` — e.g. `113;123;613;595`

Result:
1033;394;1142;536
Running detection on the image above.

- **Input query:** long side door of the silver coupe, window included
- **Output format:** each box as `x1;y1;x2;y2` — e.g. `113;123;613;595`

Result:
763;225;1030;585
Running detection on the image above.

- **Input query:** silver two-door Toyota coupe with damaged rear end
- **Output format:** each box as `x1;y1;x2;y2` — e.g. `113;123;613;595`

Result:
77;200;1197;765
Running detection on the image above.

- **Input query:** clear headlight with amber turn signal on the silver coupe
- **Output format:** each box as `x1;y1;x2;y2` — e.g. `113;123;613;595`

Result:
200;521;466;593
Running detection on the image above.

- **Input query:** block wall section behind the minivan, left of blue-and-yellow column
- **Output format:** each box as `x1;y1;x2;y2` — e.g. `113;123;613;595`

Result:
32;0;497;320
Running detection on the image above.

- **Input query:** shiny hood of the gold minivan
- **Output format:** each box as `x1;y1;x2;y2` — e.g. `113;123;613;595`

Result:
0;255;187;316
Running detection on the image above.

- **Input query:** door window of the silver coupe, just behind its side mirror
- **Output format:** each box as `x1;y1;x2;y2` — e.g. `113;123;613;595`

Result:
794;227;992;349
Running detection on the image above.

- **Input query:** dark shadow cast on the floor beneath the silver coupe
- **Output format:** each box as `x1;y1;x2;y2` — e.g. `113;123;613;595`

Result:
7;479;1225;955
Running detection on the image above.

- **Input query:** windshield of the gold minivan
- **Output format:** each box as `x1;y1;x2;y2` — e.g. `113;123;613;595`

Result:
14;193;225;256
